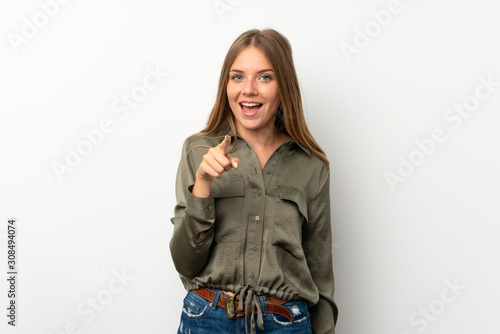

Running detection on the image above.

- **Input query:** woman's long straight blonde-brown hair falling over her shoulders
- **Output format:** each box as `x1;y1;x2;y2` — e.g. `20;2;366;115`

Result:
198;29;329;164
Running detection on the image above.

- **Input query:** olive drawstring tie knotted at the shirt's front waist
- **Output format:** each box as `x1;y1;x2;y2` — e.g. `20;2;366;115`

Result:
229;285;264;334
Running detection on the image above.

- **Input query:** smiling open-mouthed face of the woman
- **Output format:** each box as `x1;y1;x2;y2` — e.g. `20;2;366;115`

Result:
227;46;280;135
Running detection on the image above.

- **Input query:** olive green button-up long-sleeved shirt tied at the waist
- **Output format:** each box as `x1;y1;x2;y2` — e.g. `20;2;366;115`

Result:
170;135;337;334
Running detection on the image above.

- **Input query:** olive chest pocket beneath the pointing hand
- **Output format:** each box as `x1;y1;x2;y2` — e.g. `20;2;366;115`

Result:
211;172;245;243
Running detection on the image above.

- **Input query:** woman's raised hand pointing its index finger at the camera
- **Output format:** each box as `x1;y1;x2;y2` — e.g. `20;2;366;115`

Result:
192;136;240;198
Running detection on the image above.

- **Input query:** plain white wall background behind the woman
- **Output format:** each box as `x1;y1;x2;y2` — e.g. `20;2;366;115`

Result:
0;0;500;334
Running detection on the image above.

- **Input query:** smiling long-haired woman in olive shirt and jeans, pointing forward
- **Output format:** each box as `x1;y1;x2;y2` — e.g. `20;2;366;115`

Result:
170;29;337;334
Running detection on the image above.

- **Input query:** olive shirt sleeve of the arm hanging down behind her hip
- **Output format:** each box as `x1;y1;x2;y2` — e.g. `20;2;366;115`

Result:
303;165;338;334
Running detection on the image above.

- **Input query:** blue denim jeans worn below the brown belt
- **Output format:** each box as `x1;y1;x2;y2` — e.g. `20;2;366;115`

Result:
177;289;312;334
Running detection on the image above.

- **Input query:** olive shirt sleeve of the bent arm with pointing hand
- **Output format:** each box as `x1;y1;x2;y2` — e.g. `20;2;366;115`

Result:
170;139;215;279
